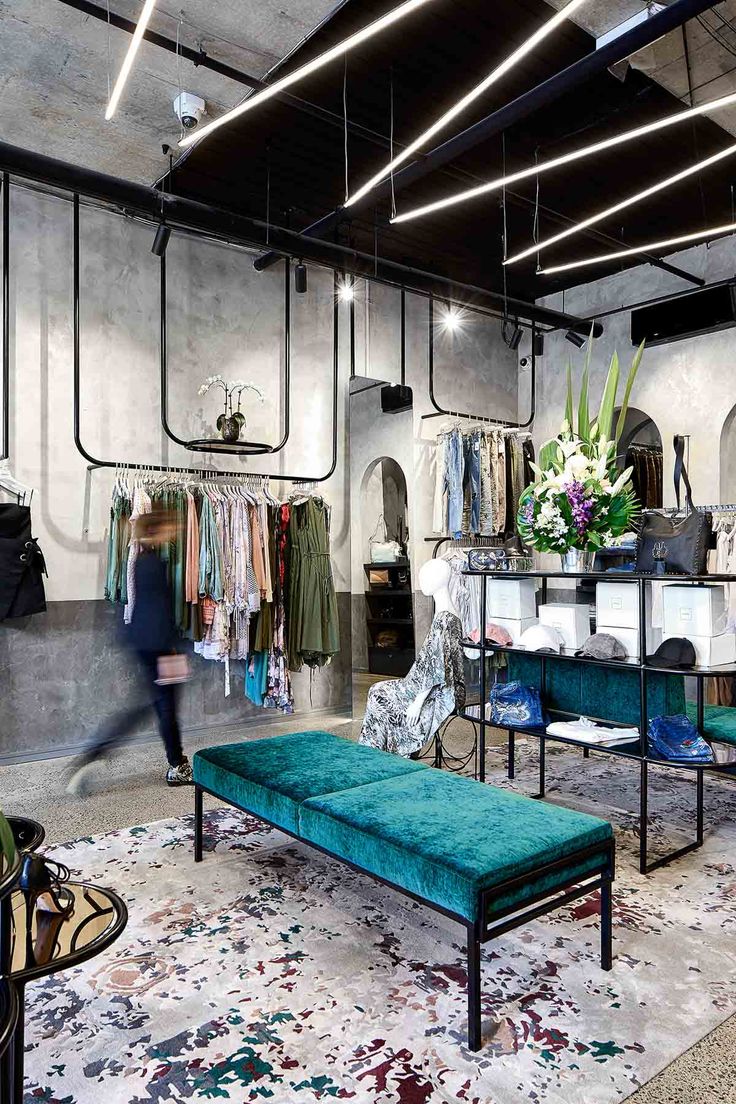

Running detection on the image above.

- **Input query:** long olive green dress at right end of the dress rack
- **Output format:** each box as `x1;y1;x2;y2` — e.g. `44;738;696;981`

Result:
287;497;340;671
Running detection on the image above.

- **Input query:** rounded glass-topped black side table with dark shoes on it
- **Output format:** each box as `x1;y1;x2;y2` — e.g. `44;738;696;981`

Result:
0;882;128;1104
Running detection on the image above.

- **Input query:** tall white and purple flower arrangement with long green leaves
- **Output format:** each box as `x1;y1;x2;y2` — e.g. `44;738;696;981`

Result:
518;335;643;556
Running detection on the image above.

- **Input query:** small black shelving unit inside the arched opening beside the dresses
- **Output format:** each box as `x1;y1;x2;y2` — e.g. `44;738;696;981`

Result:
363;560;416;678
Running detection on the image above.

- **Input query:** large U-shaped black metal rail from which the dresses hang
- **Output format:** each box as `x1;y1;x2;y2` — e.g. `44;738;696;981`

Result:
73;192;340;484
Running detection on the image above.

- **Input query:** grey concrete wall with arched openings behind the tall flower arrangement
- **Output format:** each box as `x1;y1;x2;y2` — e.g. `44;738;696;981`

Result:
534;237;736;506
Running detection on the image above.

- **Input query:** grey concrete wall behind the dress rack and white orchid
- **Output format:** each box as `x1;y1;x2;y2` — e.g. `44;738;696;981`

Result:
0;188;351;756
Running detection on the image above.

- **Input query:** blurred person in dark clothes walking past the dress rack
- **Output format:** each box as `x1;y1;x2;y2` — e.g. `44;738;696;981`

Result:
67;505;192;794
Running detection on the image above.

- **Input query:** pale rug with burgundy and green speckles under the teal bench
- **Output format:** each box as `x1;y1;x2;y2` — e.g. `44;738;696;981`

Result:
25;745;736;1104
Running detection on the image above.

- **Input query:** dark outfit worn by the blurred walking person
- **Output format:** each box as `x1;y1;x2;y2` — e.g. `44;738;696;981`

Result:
84;551;184;766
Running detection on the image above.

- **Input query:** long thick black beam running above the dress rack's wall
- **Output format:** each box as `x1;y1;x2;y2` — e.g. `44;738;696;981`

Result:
0;135;602;337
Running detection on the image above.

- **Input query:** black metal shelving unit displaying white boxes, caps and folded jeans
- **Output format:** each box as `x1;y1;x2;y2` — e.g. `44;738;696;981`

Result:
458;571;736;874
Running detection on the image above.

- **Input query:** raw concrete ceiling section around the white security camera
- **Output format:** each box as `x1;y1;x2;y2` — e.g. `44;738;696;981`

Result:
0;0;339;183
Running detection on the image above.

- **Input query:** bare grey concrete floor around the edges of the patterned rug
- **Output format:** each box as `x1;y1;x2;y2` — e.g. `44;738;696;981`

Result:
0;706;736;1104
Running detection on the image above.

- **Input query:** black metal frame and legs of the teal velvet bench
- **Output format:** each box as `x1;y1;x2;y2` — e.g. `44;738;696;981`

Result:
194;783;616;1051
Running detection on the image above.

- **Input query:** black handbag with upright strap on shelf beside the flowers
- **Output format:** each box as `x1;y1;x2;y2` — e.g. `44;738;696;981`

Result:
637;436;713;575
